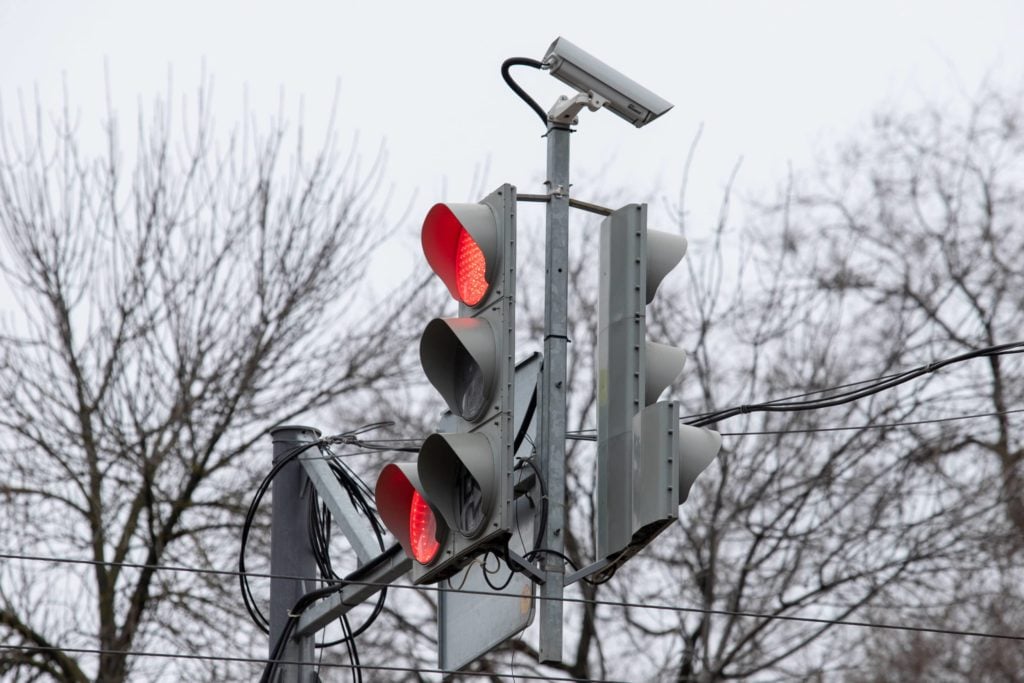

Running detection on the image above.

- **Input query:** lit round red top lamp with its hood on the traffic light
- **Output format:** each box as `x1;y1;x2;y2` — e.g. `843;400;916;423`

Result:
421;204;498;306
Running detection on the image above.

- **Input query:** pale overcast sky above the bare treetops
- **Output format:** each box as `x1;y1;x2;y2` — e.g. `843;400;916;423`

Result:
0;0;1024;253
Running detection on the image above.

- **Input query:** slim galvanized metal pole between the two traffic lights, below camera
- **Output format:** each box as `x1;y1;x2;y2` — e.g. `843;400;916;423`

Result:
539;123;569;661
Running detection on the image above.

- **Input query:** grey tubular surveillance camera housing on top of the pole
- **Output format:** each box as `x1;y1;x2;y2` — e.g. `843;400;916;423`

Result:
544;36;673;128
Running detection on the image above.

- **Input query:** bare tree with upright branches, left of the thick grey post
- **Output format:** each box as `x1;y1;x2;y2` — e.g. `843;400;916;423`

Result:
0;85;423;681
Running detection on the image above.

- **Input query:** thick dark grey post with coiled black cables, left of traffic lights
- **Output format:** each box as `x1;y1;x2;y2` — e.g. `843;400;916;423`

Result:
269;426;321;683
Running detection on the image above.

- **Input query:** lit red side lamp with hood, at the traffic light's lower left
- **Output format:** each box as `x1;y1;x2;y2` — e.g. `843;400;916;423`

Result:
375;463;445;564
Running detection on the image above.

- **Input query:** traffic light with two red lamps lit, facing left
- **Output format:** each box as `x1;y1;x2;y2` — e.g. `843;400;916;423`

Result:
377;184;516;584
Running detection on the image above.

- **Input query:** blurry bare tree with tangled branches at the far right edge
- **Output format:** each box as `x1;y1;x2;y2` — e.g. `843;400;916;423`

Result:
774;87;1024;680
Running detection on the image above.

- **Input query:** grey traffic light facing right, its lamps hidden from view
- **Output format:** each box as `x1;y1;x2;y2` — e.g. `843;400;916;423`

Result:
596;204;721;563
